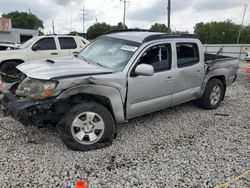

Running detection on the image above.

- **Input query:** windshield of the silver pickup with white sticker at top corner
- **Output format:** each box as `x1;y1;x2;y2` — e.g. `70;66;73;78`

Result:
78;36;140;71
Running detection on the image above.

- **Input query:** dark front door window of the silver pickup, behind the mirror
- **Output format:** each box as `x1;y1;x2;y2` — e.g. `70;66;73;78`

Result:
139;44;171;72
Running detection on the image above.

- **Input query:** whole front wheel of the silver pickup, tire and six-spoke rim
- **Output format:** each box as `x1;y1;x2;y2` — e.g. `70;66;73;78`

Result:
58;102;115;151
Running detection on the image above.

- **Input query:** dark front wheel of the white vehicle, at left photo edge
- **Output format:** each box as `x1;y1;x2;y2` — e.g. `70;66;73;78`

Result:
0;61;20;83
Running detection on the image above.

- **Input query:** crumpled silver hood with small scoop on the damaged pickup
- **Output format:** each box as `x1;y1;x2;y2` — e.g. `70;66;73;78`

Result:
17;57;114;80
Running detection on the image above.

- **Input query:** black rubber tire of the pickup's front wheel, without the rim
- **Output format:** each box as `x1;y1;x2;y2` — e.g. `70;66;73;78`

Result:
57;102;116;151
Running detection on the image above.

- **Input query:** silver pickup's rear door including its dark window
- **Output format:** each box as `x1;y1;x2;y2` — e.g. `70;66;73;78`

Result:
173;42;205;105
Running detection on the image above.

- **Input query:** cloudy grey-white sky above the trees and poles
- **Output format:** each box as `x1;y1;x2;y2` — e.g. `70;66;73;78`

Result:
0;0;250;34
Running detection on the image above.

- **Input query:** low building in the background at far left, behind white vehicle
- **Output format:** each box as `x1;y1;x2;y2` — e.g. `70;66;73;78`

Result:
0;18;38;43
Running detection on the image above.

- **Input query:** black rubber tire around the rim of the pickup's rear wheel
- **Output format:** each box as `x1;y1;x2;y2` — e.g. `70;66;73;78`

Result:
196;78;225;110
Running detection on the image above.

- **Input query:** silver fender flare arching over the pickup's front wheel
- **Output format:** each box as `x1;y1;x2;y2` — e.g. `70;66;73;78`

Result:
57;84;125;123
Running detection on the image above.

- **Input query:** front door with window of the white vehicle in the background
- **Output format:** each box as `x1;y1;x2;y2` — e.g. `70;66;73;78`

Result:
29;37;58;61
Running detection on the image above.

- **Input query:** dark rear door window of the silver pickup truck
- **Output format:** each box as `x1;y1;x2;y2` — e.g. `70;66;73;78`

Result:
176;43;199;68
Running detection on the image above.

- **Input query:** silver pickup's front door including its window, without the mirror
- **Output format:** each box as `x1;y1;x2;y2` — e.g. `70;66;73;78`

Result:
127;44;173;118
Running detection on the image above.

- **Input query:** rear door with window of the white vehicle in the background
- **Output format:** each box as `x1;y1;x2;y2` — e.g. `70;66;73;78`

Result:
58;37;79;57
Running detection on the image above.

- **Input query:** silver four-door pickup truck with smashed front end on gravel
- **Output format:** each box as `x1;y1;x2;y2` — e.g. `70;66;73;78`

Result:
0;30;239;151
